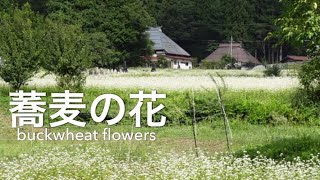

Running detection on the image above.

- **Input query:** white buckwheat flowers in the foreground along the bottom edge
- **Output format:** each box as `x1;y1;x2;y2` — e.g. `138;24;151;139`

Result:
0;145;320;180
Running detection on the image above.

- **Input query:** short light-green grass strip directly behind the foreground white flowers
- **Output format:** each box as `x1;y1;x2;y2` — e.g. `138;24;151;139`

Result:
0;122;320;161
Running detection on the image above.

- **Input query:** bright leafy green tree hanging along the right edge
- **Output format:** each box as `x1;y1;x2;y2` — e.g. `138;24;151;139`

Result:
270;0;320;102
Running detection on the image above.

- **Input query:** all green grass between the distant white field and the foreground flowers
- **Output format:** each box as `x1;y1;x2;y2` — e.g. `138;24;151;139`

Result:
0;87;320;160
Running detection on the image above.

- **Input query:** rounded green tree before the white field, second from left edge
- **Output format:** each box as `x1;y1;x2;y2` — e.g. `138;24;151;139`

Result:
42;20;91;90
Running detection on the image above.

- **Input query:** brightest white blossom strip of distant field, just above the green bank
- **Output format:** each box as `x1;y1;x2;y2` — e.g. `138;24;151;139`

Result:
10;75;299;90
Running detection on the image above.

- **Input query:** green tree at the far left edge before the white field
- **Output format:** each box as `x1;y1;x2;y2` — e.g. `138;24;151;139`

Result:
0;4;41;90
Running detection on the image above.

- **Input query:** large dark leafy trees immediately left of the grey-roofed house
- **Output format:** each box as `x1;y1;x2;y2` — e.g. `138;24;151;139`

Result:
48;0;154;66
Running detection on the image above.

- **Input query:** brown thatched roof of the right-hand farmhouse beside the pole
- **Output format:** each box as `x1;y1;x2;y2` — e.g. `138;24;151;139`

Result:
204;43;261;64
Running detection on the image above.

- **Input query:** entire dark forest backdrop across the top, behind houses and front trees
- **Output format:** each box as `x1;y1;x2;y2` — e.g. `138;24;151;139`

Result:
0;0;304;67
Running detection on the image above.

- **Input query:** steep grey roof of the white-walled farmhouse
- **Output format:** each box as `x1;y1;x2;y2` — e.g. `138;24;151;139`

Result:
147;27;190;56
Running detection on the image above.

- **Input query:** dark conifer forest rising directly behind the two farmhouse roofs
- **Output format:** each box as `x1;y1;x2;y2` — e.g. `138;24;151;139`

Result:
144;0;285;60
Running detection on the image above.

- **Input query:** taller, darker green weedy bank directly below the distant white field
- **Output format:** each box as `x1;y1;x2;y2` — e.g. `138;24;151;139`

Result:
13;88;320;126
